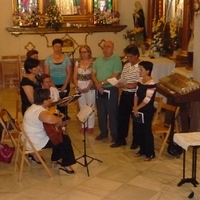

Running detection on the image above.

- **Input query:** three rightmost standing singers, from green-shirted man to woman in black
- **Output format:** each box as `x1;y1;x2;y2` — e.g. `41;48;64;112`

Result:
92;41;156;161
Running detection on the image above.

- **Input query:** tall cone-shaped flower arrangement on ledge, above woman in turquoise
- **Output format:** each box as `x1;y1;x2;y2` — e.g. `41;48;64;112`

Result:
45;3;63;30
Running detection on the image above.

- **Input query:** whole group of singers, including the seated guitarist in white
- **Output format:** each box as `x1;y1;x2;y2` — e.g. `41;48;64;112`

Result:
20;39;156;174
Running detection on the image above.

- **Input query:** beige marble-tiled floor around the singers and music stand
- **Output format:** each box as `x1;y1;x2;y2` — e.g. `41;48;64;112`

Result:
0;88;200;200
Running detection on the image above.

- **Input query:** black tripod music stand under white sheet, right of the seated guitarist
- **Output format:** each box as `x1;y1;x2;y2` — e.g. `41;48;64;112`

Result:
76;105;103;176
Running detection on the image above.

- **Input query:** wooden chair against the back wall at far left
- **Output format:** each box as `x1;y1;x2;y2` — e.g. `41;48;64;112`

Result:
2;55;20;87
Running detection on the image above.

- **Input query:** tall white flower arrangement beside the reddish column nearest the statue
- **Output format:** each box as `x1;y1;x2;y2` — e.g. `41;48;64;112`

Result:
149;17;165;55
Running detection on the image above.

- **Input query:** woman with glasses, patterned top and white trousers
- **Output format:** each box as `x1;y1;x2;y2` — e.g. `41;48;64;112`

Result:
73;45;95;133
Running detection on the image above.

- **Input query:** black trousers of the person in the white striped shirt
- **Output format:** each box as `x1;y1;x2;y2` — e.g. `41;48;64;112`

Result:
117;91;138;144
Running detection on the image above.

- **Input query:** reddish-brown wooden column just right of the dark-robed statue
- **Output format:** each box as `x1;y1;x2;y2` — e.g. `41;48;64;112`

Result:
146;0;156;43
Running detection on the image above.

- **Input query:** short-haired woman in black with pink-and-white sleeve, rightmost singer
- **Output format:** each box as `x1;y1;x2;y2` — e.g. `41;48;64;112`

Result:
133;61;156;161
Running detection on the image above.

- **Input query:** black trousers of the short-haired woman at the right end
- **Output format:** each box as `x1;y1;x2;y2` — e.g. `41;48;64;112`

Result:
134;113;155;157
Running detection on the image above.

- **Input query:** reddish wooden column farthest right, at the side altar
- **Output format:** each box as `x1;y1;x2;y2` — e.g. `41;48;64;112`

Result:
181;0;193;57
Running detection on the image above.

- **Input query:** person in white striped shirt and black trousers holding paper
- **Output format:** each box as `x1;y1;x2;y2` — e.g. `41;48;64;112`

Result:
110;44;140;149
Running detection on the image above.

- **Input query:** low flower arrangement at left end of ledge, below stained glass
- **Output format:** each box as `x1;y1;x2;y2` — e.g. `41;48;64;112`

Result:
12;9;40;26
